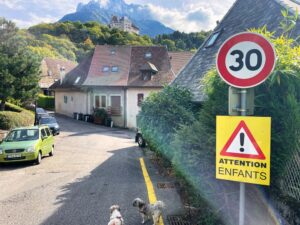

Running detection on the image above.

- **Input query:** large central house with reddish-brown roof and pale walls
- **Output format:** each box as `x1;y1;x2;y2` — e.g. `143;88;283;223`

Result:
52;45;192;128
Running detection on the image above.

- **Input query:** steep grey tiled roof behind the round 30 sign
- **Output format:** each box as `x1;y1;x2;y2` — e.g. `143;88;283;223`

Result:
172;0;300;102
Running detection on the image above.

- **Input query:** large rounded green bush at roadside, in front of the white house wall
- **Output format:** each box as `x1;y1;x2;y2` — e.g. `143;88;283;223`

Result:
138;86;195;161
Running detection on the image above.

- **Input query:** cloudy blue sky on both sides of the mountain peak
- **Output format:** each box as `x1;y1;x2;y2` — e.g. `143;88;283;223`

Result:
0;0;234;32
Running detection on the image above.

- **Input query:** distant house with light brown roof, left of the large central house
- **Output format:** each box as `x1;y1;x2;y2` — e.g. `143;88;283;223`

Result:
39;58;77;95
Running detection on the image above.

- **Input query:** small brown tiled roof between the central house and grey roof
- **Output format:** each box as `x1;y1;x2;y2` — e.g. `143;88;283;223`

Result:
169;51;195;75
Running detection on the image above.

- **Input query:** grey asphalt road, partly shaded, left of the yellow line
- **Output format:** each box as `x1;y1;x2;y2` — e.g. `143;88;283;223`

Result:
0;117;180;225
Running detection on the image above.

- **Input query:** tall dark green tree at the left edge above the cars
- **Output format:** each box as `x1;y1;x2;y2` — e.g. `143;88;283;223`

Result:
0;19;40;111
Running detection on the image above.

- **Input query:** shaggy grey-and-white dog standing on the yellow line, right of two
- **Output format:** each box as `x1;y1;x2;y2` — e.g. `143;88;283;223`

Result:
132;198;165;225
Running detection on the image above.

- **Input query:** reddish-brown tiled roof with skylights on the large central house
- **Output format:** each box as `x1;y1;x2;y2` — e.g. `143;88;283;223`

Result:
52;45;188;89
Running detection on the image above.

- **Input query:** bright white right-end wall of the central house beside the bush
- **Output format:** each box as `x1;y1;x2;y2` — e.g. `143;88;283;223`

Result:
127;88;161;129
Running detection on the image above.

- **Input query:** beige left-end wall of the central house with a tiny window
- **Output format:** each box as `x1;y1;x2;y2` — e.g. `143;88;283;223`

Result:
55;91;90;117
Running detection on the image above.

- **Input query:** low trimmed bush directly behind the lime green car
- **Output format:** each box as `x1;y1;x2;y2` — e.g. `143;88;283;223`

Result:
0;110;34;130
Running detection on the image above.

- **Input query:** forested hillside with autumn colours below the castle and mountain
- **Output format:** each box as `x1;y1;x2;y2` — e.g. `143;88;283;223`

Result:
19;21;209;61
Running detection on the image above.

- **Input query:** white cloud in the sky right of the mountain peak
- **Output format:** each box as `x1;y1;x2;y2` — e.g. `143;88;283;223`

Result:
126;0;234;32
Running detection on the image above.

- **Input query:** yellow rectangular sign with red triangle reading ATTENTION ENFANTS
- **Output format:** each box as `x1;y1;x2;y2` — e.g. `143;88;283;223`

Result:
216;116;271;185
